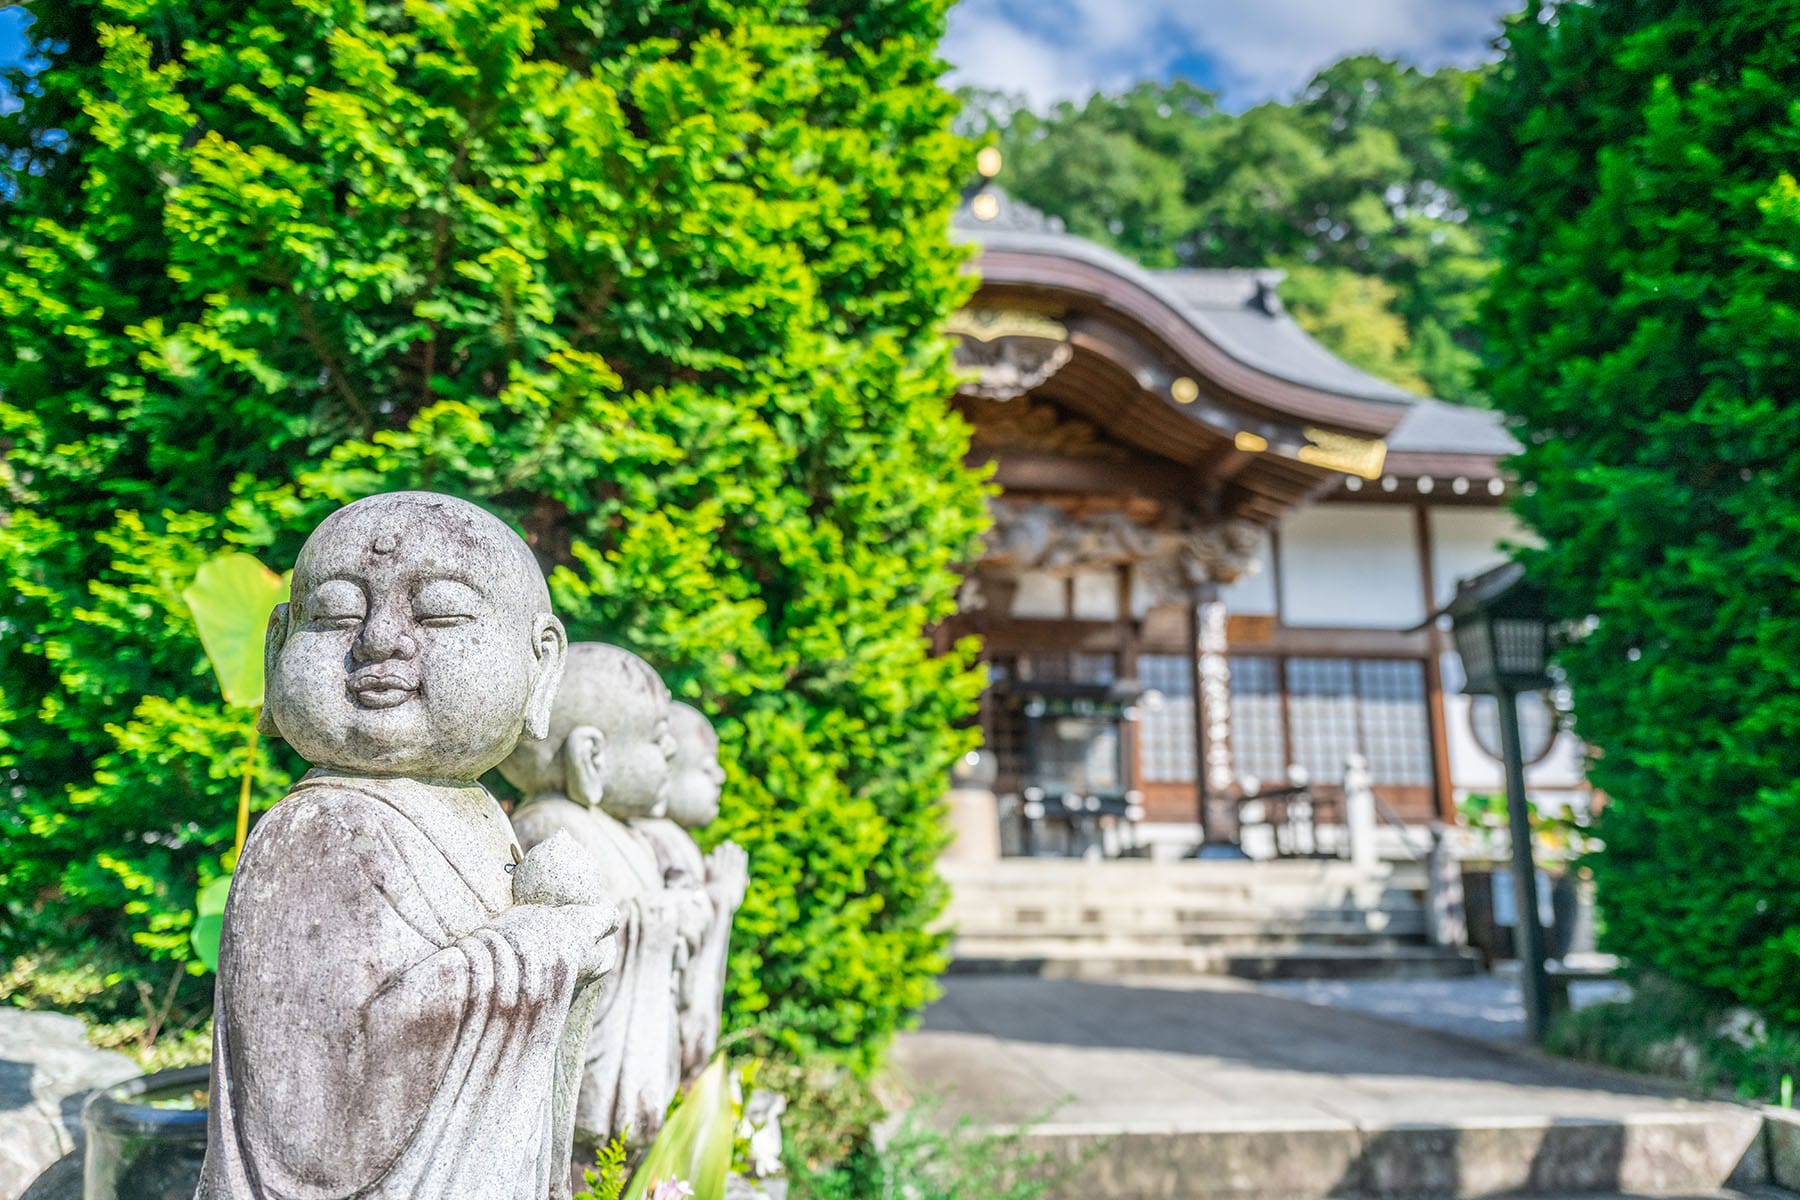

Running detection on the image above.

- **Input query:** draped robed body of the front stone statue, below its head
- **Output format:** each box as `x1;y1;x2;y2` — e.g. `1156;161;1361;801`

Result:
198;770;592;1200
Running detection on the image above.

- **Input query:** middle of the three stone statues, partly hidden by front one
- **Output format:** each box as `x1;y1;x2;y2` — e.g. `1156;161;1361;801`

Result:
500;642;709;1146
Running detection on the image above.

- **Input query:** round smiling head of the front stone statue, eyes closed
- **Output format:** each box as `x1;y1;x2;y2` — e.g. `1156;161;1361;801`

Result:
265;491;563;779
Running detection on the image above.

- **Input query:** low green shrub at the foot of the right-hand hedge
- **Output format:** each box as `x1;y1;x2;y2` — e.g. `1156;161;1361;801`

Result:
1548;973;1800;1103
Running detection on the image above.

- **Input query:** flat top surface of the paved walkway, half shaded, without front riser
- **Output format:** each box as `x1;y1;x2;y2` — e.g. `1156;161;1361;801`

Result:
898;975;1696;1128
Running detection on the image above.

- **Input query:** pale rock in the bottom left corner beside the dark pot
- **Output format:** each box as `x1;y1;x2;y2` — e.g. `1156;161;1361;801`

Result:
0;1007;139;1200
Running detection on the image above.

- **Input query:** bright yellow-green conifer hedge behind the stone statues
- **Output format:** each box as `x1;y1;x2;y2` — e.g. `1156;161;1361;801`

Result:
0;0;985;1069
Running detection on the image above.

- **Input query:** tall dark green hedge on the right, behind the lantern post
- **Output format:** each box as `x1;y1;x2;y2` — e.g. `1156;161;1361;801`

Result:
1467;0;1800;1024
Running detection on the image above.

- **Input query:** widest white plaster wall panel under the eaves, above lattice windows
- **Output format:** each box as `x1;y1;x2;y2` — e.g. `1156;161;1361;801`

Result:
1281;504;1426;630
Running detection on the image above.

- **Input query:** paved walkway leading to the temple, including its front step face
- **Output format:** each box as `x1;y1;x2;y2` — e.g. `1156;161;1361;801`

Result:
896;975;1766;1200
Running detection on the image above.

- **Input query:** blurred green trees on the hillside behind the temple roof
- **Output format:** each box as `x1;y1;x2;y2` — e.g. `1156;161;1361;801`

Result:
967;56;1490;401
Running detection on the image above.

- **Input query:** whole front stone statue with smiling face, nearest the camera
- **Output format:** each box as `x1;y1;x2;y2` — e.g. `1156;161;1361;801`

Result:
198;493;617;1200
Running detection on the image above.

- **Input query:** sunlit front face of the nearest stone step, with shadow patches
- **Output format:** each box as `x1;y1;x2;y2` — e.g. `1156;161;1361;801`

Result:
1026;1106;1780;1200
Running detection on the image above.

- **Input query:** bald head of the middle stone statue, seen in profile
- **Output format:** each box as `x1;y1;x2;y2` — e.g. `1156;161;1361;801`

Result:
500;642;675;817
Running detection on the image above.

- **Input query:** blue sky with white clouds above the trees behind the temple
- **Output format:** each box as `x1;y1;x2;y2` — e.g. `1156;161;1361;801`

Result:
943;0;1521;108
